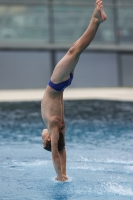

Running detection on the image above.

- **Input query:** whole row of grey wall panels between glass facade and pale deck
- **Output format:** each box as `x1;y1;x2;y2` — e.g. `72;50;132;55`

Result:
0;51;133;89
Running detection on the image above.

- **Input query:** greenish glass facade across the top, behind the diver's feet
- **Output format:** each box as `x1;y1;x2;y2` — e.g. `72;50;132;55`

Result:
0;0;133;45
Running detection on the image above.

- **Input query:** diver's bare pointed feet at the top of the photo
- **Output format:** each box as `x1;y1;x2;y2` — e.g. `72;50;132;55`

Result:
92;0;107;23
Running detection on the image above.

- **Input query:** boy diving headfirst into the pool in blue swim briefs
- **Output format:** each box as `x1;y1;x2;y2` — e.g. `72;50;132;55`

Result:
41;0;106;181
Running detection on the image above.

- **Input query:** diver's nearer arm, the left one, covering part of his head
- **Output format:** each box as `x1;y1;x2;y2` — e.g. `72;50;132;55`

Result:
51;131;62;181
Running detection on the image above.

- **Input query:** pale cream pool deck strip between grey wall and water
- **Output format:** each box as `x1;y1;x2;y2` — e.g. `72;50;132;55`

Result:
0;88;133;102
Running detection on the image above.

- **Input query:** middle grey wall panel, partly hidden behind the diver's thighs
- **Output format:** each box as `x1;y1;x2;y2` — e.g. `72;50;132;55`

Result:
57;52;118;87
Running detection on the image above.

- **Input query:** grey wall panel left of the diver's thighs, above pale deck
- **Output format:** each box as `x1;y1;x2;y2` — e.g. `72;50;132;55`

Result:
0;52;51;89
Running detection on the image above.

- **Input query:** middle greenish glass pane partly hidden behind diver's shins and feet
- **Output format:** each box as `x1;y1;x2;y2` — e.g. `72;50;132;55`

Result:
54;5;114;43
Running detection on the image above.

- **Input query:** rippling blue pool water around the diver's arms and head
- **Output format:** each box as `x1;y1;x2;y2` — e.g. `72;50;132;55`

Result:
0;101;133;200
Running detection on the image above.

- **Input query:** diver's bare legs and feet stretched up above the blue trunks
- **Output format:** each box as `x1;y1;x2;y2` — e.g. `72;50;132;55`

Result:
51;0;106;83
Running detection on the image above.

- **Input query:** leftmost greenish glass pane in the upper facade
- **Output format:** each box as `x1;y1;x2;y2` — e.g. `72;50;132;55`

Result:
0;6;48;41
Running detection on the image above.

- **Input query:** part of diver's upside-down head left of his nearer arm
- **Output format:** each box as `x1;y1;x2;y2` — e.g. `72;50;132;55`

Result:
42;129;51;151
